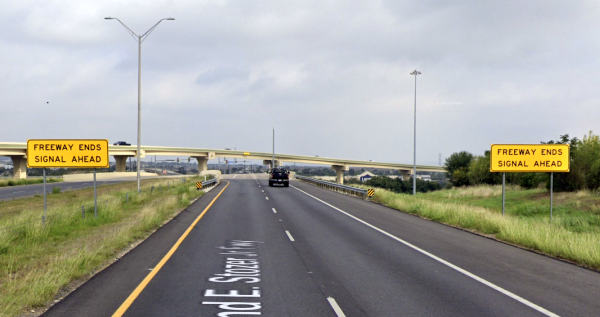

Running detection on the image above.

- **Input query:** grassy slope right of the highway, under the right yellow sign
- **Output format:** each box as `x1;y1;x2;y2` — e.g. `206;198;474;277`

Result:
374;186;600;270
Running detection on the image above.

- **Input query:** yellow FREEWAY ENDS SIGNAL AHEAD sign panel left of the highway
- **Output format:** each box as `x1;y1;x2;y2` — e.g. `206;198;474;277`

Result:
27;139;109;168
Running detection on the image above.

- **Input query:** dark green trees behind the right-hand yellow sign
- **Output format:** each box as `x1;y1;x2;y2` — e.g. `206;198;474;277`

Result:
444;131;600;191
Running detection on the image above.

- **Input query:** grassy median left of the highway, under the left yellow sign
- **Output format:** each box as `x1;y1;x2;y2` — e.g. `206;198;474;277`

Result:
0;178;204;316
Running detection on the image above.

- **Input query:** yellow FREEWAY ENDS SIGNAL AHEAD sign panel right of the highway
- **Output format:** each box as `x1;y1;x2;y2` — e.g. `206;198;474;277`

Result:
490;144;569;172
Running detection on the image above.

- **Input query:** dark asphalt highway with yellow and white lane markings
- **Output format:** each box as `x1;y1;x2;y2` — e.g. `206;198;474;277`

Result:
45;174;600;317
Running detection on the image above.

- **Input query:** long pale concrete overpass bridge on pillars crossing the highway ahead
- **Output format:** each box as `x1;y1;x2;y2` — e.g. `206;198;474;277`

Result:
0;142;445;184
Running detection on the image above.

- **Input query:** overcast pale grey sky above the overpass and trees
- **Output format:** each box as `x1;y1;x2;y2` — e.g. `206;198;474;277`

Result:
0;0;600;165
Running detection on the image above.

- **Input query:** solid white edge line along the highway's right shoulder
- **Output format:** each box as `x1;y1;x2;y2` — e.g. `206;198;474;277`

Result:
292;186;559;317
